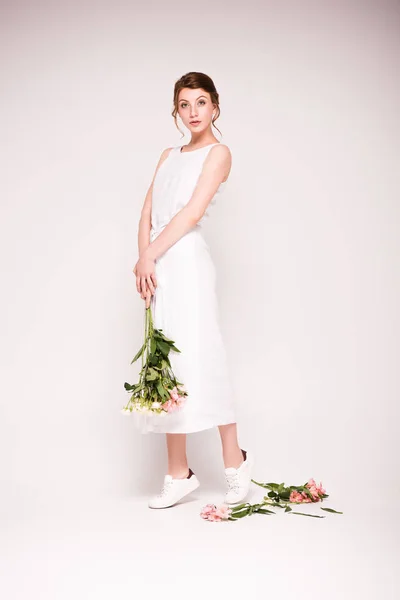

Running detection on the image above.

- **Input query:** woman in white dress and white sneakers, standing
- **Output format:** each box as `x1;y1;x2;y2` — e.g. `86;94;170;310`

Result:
133;72;253;508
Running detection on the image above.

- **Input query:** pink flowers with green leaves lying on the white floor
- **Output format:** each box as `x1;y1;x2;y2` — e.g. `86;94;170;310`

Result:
200;479;343;521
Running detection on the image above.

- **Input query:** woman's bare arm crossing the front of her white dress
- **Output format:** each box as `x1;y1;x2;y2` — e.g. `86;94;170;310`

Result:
141;144;232;262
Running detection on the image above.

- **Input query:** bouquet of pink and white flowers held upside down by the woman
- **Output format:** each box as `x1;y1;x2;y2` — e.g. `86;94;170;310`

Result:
122;305;188;416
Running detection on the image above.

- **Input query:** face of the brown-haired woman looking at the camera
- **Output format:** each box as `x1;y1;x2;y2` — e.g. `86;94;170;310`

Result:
178;88;214;133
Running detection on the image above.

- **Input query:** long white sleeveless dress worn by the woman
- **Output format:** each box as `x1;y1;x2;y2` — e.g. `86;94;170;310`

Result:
132;142;236;433
